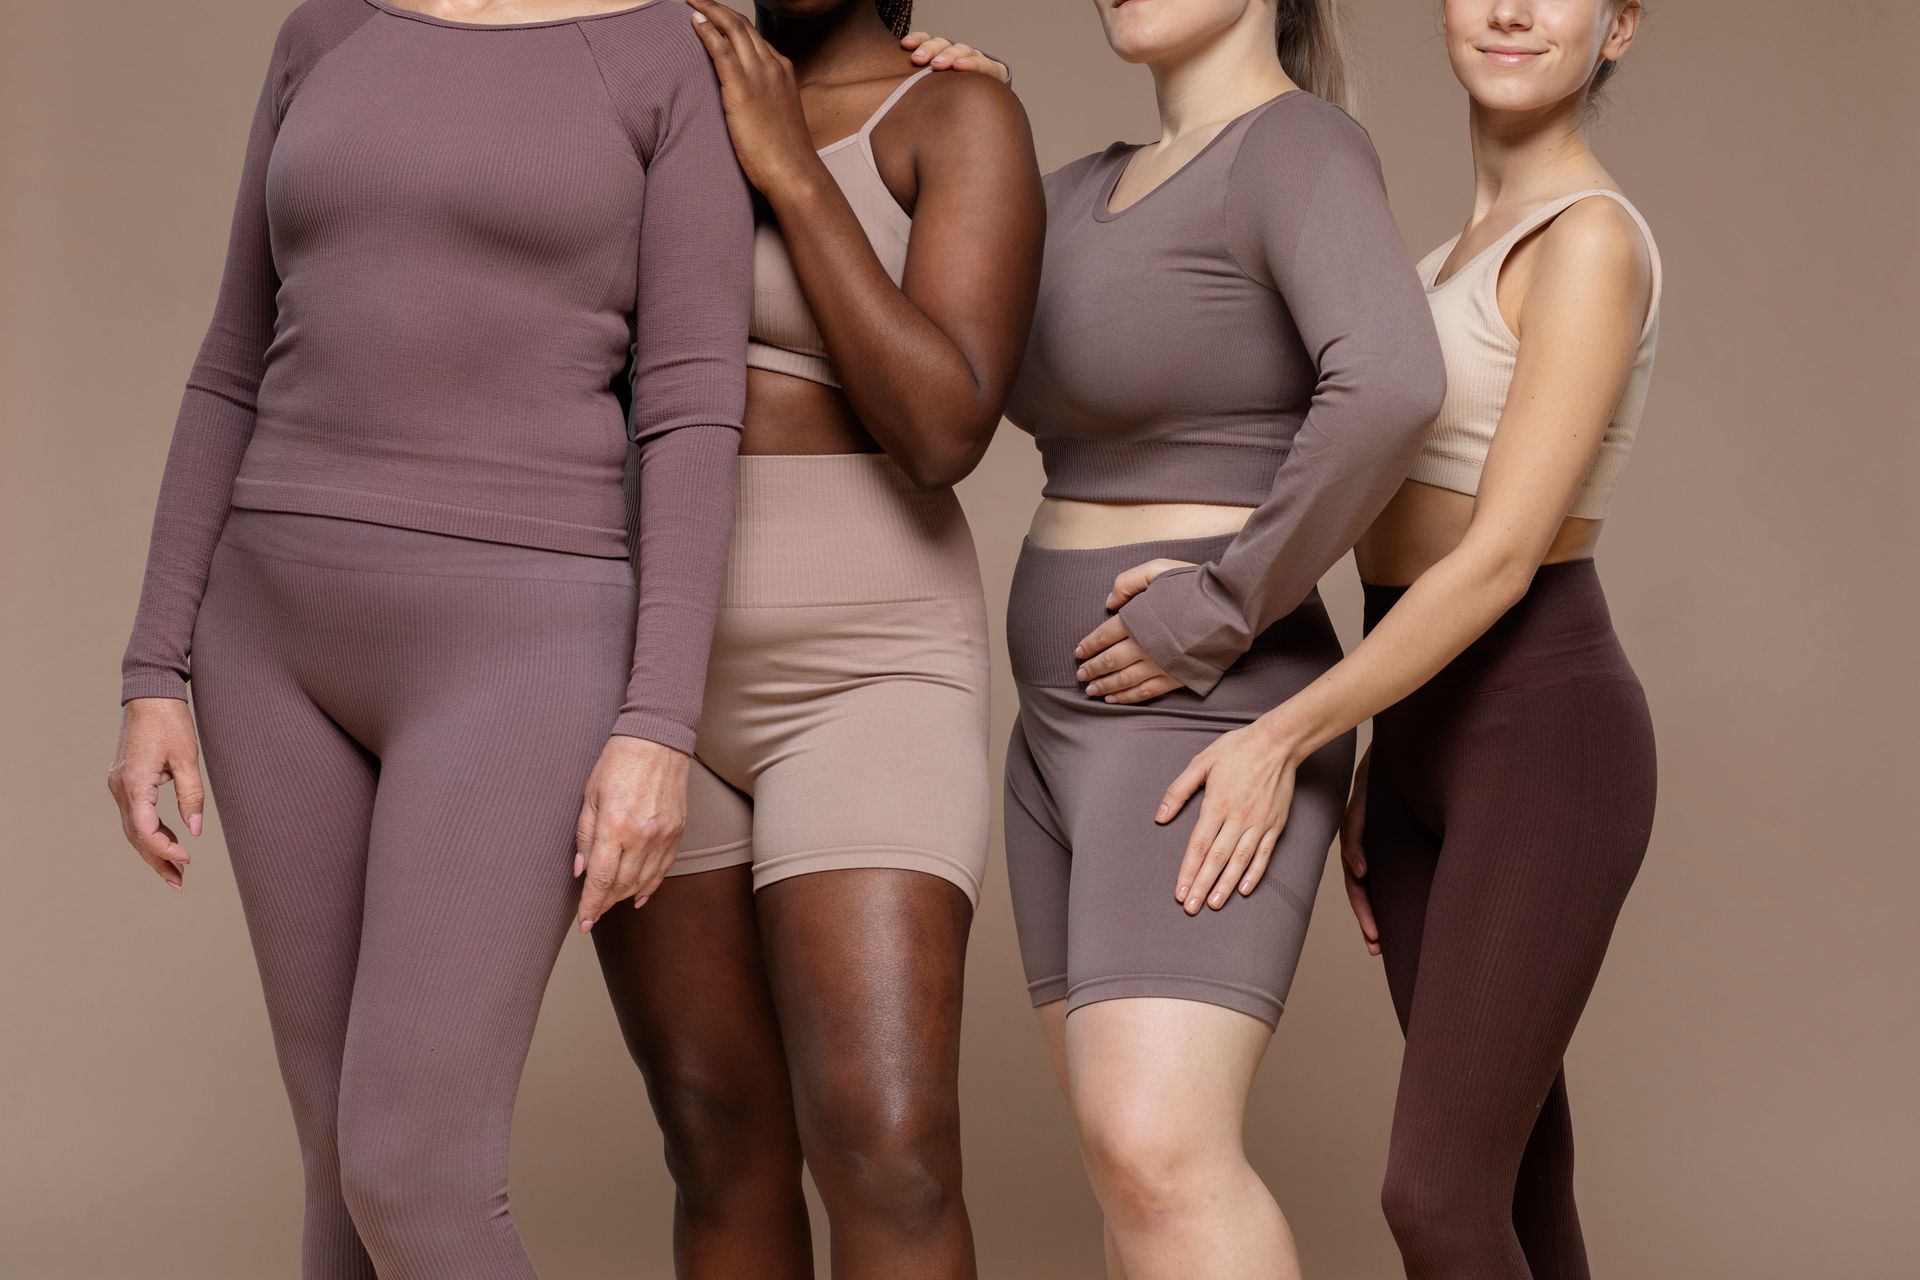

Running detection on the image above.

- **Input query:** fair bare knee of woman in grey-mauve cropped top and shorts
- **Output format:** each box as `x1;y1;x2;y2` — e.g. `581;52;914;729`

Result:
1075;1107;1217;1234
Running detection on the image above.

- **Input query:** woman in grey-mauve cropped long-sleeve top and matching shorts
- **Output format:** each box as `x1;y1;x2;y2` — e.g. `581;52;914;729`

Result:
1006;0;1444;1280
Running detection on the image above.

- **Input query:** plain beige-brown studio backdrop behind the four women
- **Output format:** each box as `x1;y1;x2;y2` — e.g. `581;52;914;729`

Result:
0;0;1920;1280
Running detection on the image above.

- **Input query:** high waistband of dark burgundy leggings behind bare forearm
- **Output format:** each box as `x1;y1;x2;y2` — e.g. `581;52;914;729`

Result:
1365;560;1638;700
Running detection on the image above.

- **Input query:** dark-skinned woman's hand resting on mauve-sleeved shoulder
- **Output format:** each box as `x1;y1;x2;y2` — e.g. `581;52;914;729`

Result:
687;0;824;196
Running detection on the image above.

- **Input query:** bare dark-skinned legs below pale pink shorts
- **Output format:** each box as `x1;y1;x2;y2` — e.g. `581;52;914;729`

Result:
593;864;973;1280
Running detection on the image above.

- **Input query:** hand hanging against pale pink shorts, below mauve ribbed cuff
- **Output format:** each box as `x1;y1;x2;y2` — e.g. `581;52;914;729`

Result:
574;737;689;933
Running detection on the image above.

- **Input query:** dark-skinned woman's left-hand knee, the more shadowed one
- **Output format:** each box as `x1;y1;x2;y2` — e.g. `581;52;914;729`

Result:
653;1073;801;1213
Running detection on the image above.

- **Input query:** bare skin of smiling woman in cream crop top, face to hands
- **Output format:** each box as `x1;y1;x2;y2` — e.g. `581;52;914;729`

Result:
1158;0;1653;940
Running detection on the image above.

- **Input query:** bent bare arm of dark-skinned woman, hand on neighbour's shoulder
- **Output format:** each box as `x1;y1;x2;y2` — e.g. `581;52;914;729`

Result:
693;0;1046;486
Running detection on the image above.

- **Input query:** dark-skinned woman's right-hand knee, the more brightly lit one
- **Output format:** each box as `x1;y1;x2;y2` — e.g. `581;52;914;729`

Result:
806;1090;960;1232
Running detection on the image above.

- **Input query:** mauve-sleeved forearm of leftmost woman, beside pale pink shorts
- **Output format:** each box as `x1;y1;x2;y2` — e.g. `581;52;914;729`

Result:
612;426;739;754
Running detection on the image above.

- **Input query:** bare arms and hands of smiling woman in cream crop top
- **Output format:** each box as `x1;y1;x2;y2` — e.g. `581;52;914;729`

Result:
1158;200;1653;909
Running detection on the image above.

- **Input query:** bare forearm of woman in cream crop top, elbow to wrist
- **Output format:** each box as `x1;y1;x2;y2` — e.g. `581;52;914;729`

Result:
1256;543;1534;764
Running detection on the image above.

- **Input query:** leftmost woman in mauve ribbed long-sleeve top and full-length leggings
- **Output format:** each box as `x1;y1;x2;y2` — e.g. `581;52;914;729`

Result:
111;0;753;1280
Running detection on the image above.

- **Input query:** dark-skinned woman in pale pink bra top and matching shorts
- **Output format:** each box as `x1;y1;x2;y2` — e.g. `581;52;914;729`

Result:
593;0;1044;1280
